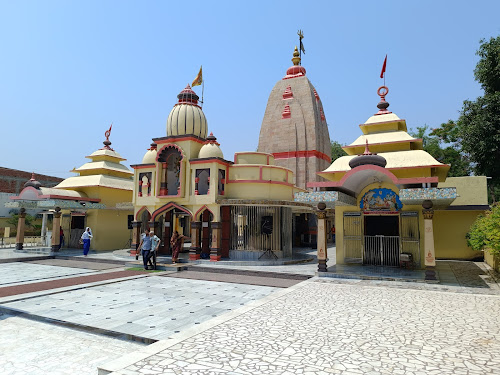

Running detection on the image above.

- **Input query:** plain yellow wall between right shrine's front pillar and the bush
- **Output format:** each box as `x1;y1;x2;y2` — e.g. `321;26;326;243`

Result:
433;210;482;259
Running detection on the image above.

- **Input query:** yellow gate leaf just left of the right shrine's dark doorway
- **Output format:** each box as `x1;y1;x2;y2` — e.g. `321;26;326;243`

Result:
344;212;363;263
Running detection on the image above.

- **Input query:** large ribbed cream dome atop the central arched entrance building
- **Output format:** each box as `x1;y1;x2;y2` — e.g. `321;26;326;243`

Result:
167;85;207;139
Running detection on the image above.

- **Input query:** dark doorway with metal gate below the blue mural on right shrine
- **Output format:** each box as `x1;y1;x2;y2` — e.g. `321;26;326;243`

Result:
363;215;399;266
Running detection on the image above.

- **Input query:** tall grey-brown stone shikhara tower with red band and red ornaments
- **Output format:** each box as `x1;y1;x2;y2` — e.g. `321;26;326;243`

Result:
258;47;331;189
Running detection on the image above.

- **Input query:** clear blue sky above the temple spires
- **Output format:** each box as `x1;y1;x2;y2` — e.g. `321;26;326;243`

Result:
0;0;500;177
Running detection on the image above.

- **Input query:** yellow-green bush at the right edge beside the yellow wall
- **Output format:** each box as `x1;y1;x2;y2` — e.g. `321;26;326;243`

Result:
467;204;500;255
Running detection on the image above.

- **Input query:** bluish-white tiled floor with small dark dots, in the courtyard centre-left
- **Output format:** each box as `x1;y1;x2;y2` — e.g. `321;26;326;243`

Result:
1;276;276;340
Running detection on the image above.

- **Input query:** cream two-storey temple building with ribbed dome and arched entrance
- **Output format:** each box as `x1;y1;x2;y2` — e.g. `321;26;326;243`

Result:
131;85;311;261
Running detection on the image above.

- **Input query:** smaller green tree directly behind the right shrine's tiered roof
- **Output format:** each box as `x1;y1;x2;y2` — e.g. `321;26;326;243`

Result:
410;122;472;177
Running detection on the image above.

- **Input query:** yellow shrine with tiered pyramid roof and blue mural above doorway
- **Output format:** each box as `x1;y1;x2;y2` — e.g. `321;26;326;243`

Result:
295;86;488;271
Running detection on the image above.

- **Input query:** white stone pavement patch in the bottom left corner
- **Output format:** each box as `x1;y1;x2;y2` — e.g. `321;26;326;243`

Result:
0;314;144;375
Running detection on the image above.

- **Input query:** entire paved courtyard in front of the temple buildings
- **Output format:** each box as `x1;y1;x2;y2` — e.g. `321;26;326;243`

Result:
0;250;500;375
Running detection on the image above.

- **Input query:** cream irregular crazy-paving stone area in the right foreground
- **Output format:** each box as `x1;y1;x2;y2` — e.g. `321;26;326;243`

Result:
100;279;500;375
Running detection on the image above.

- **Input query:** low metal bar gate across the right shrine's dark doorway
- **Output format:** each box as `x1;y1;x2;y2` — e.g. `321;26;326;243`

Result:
363;235;399;266
